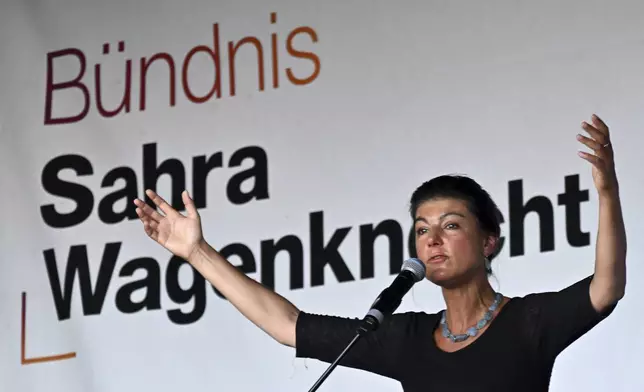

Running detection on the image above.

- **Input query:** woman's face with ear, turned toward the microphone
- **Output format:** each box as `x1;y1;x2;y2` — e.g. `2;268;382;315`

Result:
414;198;495;287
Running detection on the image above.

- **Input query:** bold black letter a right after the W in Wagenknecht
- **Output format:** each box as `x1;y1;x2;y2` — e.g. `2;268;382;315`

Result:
115;257;161;313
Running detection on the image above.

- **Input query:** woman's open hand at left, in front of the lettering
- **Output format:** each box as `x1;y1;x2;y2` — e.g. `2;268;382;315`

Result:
134;189;203;261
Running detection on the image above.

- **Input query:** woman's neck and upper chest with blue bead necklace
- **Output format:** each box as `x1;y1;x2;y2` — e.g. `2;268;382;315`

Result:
443;278;495;334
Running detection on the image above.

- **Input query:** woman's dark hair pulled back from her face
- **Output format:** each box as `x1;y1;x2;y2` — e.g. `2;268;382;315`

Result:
409;175;502;274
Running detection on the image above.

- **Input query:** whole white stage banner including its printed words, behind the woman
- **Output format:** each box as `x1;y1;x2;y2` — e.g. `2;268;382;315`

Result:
0;0;644;392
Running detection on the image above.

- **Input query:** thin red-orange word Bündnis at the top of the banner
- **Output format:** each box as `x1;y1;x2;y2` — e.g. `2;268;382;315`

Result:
44;12;320;125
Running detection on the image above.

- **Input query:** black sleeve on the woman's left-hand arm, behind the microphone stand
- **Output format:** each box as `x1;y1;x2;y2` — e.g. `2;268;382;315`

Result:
295;312;417;380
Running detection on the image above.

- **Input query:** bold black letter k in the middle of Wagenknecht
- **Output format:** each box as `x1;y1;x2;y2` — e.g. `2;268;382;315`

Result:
309;211;355;286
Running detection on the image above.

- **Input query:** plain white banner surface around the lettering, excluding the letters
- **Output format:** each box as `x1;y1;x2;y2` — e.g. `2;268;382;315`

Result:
0;0;644;392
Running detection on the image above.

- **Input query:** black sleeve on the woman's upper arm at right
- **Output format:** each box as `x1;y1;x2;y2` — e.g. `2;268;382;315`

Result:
528;275;617;359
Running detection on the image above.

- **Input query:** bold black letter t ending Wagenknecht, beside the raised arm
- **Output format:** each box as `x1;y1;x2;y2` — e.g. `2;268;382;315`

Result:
557;174;590;247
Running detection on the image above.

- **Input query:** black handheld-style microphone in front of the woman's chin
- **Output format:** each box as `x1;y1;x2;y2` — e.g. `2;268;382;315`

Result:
358;258;425;333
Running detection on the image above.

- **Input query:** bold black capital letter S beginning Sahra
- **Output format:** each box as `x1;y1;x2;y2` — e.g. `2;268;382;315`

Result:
40;155;94;229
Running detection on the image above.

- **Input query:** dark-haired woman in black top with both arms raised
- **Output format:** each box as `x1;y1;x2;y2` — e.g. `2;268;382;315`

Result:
134;115;626;392
